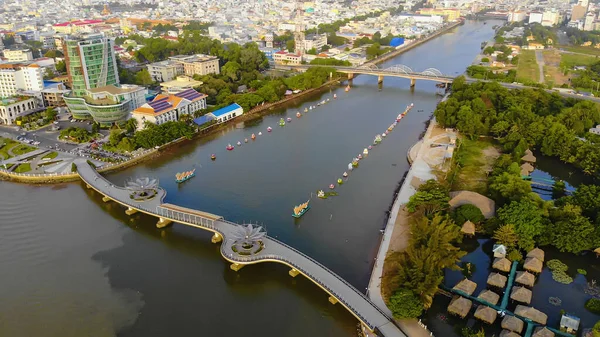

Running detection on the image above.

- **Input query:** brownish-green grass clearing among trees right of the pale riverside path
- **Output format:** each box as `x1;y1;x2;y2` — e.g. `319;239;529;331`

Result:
448;138;500;195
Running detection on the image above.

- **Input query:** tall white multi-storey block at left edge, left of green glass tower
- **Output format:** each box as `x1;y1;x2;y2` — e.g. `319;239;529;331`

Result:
0;63;44;97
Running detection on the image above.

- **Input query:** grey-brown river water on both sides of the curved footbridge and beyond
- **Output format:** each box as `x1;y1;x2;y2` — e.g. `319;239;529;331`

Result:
0;22;502;336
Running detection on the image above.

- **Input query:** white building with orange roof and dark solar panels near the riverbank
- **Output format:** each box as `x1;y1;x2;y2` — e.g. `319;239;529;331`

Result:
131;89;207;128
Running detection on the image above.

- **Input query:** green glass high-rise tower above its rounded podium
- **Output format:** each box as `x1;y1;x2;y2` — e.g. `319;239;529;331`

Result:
62;34;119;96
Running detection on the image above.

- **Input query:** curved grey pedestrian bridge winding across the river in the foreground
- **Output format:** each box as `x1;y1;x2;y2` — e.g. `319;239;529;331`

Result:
75;160;406;337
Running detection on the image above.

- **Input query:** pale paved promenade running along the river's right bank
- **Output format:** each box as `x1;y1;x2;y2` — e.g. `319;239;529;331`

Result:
367;118;437;337
